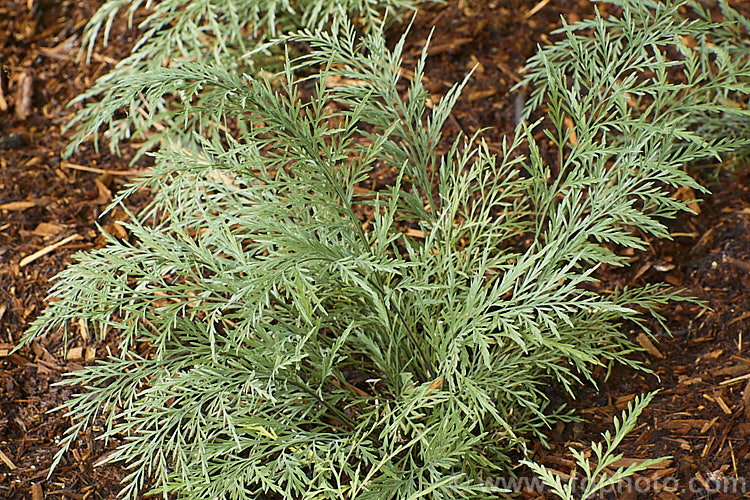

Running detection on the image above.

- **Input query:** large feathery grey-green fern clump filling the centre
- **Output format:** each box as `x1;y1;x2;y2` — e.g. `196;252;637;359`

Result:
20;0;748;499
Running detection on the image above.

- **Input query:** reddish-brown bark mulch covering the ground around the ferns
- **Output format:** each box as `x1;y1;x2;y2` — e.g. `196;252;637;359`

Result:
0;0;750;500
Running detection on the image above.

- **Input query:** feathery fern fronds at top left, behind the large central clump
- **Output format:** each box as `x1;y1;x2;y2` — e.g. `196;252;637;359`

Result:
66;0;432;155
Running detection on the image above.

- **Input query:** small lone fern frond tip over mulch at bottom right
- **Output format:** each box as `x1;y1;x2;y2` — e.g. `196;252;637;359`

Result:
521;392;671;500
